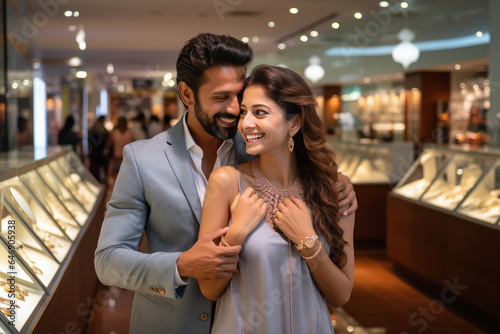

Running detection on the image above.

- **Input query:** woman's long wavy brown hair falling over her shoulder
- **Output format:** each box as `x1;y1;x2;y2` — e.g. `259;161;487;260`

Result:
243;65;347;268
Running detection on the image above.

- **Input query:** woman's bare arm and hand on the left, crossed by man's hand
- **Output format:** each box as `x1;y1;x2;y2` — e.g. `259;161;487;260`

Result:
198;167;267;300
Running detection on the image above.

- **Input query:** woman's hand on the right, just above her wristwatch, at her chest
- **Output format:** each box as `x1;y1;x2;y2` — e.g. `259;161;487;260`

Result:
274;196;316;245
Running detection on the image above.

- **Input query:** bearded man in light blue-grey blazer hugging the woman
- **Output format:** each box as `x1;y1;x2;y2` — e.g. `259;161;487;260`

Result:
95;34;357;334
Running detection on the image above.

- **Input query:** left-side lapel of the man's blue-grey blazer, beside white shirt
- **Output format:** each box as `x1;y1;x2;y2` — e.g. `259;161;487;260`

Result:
165;119;201;223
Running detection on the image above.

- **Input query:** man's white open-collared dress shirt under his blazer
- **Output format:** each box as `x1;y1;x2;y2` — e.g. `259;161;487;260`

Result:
174;112;234;288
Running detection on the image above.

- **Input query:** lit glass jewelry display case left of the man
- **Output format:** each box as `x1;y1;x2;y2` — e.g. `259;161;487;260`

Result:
0;148;103;333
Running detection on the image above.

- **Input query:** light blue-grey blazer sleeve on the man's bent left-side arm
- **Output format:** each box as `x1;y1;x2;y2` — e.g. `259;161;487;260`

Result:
94;145;185;299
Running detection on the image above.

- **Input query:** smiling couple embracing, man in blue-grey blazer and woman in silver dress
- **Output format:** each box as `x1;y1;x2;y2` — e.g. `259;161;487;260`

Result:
95;34;357;333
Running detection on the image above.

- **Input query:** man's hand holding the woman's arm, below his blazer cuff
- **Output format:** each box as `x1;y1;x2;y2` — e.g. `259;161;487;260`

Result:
177;227;241;279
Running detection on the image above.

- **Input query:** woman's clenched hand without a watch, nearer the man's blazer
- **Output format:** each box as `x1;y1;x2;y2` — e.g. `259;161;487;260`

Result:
226;187;267;245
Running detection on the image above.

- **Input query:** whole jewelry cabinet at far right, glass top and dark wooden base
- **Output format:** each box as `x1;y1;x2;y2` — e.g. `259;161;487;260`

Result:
387;147;500;323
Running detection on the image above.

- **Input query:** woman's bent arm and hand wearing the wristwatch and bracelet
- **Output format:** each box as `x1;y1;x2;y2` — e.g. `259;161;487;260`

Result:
274;198;354;307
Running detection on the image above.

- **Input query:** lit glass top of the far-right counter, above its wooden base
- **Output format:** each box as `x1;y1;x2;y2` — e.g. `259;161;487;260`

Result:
393;147;500;226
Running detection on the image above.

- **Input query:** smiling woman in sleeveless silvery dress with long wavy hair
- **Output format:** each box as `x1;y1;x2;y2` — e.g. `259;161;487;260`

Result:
199;65;354;333
